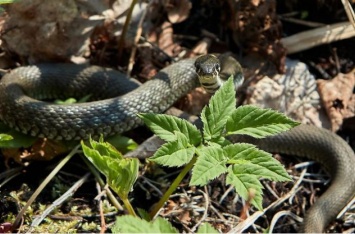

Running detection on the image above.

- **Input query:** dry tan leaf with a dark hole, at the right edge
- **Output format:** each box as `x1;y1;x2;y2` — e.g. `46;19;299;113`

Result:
317;69;355;131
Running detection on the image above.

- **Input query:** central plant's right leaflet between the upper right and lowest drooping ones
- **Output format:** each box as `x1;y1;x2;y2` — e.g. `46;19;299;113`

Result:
223;143;291;181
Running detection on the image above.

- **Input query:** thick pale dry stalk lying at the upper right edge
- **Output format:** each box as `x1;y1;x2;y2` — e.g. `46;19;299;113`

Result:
281;22;355;54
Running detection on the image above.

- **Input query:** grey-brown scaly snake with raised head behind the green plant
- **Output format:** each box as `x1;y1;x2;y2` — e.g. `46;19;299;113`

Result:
0;55;355;232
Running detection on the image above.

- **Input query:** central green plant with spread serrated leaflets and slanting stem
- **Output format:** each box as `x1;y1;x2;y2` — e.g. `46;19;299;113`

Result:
82;78;299;230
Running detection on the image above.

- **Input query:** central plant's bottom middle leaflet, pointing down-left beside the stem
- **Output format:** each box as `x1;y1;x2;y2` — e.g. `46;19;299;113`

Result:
190;146;227;186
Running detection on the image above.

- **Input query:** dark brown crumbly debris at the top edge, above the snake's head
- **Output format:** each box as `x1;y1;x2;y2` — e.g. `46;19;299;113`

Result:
233;0;286;73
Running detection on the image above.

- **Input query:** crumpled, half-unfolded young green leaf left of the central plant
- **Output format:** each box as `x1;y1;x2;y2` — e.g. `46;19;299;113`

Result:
81;138;139;199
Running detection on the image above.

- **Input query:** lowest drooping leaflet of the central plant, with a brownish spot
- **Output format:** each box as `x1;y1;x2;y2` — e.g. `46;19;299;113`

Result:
226;164;263;210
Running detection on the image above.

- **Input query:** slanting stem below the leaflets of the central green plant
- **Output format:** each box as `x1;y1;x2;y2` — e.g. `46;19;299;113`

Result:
149;155;197;219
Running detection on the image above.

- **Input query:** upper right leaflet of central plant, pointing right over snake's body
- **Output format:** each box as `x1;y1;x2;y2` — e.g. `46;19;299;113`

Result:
226;105;299;138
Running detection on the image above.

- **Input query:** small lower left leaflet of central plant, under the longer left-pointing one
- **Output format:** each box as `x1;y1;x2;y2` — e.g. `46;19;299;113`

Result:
149;132;196;167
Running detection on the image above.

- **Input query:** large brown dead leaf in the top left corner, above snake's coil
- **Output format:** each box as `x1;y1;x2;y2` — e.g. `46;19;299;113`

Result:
2;0;100;63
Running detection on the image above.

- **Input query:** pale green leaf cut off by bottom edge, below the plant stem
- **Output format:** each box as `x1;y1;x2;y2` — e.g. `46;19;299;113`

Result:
112;215;178;233
